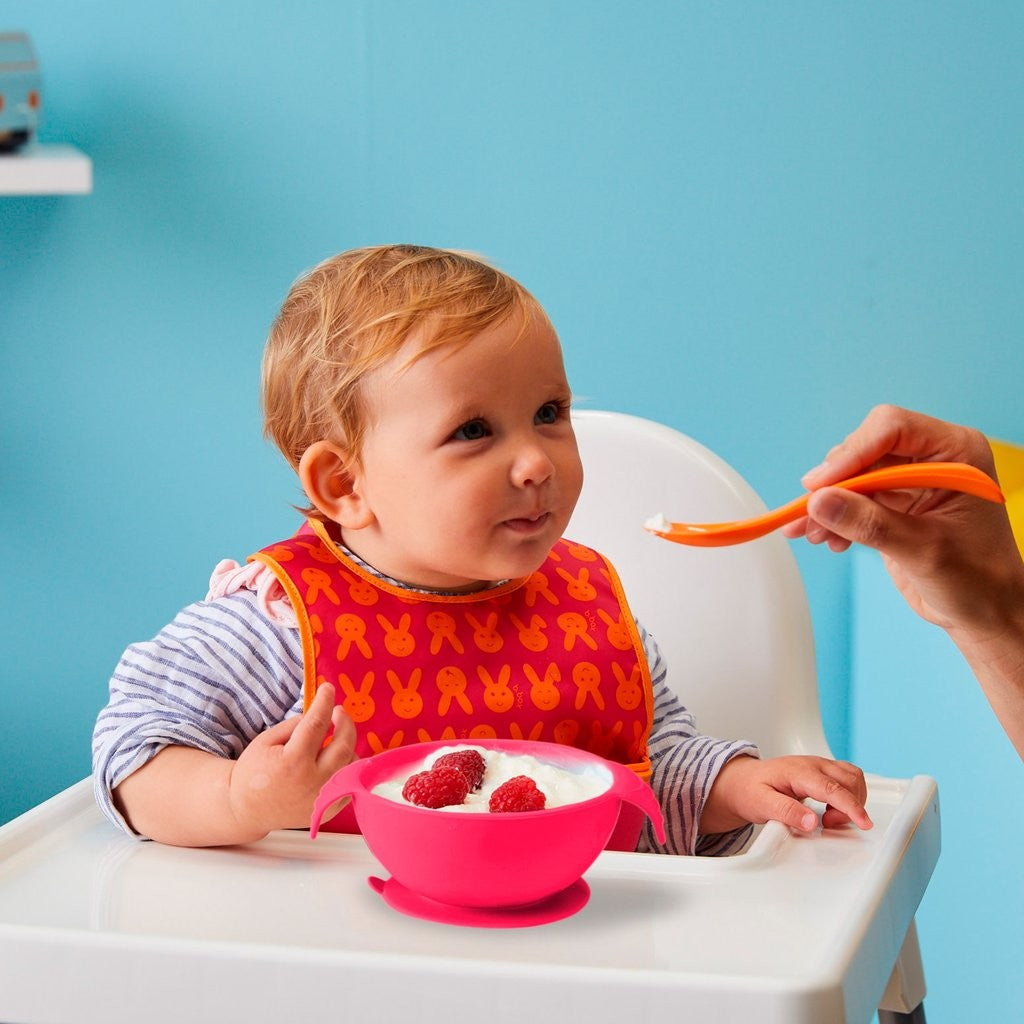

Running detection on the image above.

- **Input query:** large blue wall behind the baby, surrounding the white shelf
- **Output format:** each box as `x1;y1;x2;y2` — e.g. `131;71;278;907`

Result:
0;0;1024;1024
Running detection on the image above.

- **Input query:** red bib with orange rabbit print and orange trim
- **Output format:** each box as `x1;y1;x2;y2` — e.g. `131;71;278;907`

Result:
256;520;653;827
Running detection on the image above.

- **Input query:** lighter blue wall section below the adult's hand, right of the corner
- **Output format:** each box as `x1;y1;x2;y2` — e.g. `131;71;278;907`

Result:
850;551;1024;1024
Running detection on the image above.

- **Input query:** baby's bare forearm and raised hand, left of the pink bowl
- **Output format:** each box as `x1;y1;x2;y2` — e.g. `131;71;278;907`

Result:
114;685;355;846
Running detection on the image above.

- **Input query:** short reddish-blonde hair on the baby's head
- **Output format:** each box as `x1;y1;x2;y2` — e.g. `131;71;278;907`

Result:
262;245;544;469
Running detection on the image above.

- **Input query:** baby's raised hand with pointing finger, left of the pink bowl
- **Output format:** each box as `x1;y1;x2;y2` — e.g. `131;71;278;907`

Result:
228;684;355;835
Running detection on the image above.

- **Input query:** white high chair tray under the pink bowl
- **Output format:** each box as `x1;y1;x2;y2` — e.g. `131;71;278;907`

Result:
0;776;939;1024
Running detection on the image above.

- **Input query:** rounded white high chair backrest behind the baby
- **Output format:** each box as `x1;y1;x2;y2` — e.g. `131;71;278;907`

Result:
566;411;828;757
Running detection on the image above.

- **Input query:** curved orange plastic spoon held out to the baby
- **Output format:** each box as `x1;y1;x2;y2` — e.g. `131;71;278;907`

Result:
644;462;1006;548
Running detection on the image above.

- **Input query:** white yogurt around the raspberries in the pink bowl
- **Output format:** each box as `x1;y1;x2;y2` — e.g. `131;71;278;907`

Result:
373;743;611;811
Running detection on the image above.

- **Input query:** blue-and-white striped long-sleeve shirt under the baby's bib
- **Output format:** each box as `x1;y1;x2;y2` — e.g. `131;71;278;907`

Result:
92;565;757;855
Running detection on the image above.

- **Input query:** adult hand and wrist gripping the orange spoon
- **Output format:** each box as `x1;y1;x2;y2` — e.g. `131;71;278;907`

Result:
783;406;1024;758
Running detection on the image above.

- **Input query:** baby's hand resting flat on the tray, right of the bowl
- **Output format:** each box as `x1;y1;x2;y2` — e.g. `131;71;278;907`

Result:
700;755;873;835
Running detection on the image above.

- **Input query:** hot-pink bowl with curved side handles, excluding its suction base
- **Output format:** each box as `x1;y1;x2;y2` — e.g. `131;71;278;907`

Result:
310;739;665;907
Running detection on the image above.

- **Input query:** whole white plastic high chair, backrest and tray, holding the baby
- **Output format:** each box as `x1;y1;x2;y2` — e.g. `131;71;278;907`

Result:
0;413;939;1024
